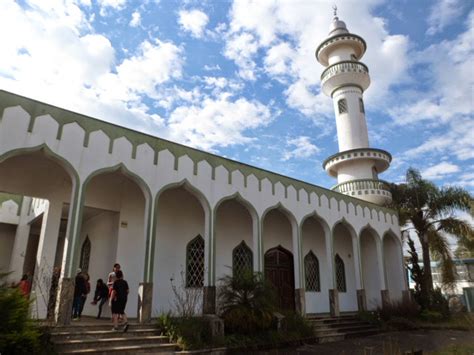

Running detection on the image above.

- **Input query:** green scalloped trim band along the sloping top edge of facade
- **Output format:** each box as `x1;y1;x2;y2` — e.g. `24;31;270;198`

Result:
0;90;396;222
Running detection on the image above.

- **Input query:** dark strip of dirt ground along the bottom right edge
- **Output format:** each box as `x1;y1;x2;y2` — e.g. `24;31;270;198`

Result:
258;330;474;355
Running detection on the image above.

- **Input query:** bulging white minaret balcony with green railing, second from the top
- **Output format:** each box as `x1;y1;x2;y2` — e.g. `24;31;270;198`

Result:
321;60;370;97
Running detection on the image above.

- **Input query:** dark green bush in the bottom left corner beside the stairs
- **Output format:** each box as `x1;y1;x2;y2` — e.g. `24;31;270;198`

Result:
0;274;44;354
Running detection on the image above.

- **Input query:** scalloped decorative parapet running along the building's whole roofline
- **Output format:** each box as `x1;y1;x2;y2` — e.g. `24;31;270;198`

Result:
0;90;396;222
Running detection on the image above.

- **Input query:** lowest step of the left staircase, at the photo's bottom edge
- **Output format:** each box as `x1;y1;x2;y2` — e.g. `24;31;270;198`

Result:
59;343;179;355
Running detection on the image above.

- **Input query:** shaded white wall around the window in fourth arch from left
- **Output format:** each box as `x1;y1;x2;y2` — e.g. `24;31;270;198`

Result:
215;200;257;280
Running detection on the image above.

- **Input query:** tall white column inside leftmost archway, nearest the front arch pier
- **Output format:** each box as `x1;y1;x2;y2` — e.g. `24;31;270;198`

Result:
33;199;62;319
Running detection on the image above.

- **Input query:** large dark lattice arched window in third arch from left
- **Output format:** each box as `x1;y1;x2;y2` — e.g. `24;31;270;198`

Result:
186;235;204;287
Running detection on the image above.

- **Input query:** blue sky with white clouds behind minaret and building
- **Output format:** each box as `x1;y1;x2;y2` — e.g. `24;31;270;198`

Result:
0;0;474;192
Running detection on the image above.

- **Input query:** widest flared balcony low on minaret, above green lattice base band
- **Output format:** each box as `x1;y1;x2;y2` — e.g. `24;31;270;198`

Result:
323;148;392;177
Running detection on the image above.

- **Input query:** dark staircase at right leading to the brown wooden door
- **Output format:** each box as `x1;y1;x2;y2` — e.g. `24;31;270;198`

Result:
307;315;380;343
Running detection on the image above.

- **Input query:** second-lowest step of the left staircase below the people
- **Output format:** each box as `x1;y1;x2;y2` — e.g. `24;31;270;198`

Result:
53;333;169;351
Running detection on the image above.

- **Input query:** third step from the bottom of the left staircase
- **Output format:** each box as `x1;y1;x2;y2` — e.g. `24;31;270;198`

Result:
51;327;159;342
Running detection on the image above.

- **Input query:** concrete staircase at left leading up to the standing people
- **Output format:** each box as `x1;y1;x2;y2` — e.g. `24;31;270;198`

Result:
51;321;179;354
